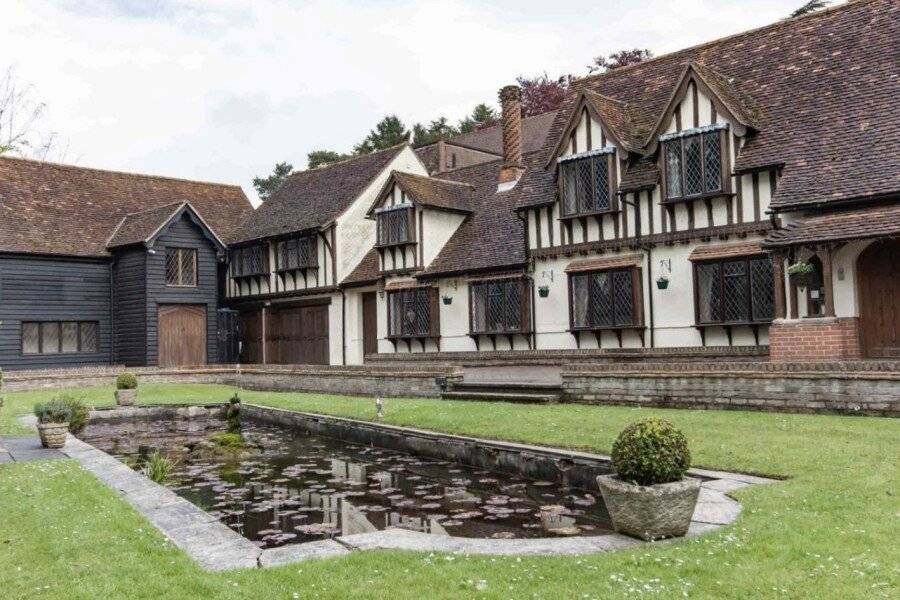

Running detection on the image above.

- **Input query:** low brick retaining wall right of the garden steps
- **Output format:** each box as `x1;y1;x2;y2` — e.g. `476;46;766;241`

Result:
562;361;900;417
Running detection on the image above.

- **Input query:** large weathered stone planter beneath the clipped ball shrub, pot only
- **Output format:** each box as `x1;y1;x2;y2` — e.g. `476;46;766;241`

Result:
597;475;700;540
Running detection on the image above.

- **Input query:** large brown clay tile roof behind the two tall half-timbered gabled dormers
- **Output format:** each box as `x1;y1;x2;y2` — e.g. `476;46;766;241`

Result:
520;0;900;210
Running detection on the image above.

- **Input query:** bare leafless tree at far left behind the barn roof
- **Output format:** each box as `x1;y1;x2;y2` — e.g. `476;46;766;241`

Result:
0;68;56;159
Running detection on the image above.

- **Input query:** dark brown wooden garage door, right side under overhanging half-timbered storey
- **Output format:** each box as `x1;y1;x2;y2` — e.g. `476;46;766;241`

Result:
274;304;328;365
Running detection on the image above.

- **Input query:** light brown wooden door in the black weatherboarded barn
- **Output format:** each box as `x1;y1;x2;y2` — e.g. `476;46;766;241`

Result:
159;304;206;367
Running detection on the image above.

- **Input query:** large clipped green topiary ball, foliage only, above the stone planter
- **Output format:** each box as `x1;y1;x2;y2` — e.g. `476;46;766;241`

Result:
612;419;691;485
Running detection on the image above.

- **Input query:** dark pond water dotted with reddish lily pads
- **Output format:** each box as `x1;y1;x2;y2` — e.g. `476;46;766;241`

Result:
89;422;611;548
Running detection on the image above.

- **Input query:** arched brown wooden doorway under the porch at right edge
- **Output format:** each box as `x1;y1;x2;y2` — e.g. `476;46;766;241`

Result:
856;239;900;358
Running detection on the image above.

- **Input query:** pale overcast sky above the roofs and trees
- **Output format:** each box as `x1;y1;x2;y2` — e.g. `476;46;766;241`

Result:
0;0;803;204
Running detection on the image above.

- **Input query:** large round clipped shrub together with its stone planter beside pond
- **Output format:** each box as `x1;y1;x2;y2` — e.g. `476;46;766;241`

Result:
597;419;700;540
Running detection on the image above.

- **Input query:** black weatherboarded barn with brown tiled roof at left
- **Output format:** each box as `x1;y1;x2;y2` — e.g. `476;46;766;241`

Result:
0;158;252;369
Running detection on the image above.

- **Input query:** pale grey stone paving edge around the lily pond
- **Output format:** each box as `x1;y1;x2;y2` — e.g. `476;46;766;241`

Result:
19;407;774;571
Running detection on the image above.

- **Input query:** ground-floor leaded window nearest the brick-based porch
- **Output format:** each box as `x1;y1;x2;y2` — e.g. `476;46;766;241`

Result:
694;257;775;324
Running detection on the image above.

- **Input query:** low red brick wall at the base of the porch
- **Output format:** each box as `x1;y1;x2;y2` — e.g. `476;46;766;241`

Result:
769;317;861;362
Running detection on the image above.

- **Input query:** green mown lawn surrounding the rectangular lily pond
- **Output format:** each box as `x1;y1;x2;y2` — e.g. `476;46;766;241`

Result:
0;385;900;600
